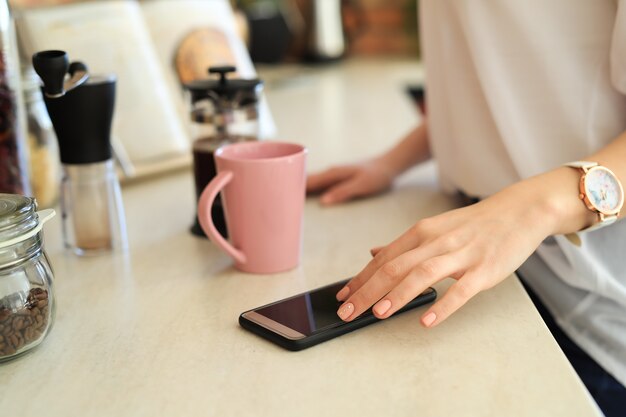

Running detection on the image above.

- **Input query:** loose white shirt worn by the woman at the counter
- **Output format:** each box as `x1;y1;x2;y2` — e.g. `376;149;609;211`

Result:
420;0;626;385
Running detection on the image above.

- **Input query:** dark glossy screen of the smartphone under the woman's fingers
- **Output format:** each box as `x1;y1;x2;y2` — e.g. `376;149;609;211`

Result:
255;281;372;336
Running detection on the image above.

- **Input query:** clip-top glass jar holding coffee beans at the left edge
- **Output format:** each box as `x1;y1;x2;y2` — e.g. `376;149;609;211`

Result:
0;194;55;362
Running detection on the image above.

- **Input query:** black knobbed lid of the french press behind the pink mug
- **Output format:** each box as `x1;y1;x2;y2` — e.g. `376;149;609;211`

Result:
185;66;263;99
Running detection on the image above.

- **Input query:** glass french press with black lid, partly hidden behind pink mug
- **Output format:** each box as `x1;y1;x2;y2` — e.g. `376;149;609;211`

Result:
185;66;263;237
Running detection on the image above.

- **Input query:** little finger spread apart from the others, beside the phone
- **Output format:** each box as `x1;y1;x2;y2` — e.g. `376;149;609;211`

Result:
420;273;481;327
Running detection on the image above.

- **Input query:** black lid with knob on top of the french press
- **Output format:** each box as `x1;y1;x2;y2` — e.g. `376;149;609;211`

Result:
185;66;263;105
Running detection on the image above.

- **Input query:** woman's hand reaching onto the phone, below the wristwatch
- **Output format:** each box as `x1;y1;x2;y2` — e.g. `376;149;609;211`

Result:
337;168;593;327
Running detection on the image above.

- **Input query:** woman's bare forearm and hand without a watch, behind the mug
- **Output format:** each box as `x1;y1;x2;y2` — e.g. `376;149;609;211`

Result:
307;123;430;205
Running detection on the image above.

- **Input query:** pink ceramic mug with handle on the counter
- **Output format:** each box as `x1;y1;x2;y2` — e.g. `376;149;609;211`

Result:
198;141;307;274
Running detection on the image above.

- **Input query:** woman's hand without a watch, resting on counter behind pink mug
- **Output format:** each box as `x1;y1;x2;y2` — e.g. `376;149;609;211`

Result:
306;159;394;205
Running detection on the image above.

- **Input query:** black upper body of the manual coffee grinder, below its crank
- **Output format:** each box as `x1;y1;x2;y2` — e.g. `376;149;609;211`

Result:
42;75;116;164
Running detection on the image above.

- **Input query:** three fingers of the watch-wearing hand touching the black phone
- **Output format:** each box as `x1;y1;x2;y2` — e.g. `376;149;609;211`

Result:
337;245;462;321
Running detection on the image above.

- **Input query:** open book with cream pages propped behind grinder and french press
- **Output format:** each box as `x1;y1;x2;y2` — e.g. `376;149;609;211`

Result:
16;0;275;177
